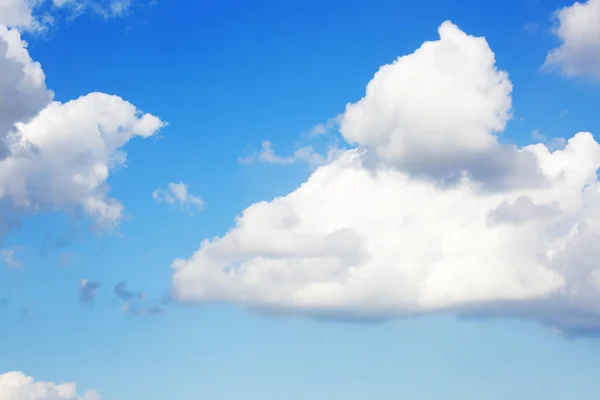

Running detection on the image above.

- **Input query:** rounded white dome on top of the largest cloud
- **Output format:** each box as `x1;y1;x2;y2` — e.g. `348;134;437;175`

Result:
340;22;524;185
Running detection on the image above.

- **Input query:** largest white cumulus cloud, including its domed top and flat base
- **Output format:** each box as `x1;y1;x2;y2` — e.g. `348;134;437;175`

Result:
172;22;600;333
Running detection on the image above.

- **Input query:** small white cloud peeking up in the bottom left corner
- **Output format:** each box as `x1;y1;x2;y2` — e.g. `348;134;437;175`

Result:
0;372;101;400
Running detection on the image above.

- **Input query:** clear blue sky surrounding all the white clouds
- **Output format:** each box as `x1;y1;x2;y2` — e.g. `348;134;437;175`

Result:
0;0;600;400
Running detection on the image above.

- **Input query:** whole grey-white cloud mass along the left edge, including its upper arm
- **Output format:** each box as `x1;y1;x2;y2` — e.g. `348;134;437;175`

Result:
0;21;164;238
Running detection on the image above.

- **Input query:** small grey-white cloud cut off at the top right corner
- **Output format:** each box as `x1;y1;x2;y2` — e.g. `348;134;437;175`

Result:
546;0;600;80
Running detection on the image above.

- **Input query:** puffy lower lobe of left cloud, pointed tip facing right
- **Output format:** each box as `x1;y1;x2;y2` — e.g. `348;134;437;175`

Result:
0;93;162;226
